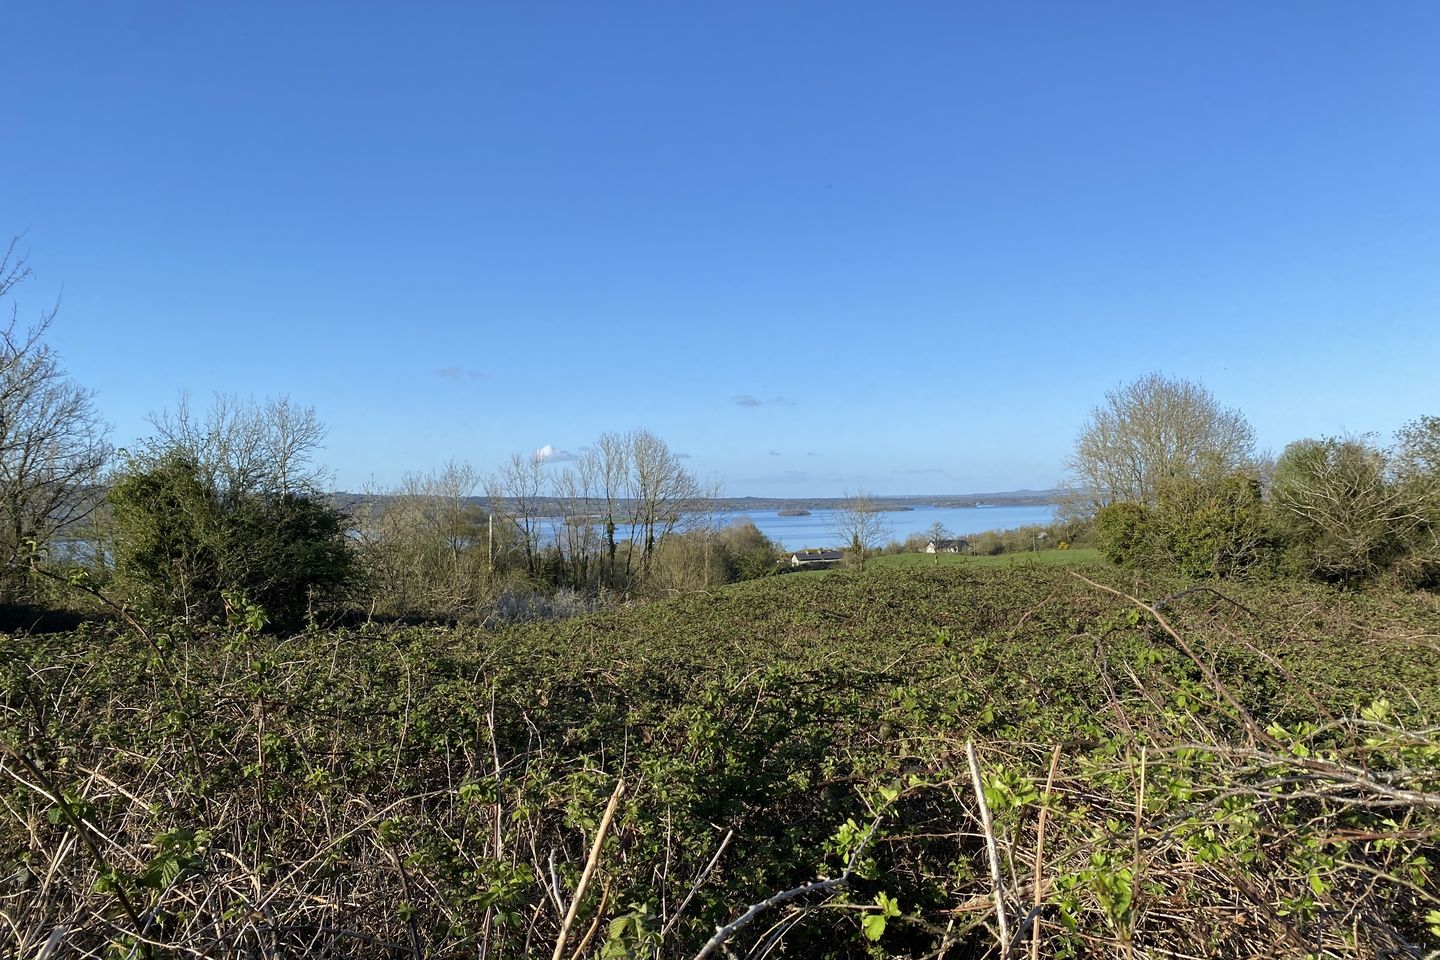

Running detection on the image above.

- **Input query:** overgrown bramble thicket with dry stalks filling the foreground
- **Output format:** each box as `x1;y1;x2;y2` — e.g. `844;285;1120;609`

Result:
0;567;1440;957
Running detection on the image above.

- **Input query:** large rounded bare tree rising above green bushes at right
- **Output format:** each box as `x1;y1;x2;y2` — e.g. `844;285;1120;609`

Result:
1066;373;1254;515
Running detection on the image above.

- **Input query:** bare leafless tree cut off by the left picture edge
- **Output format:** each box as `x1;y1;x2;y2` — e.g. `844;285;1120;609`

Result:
0;240;111;600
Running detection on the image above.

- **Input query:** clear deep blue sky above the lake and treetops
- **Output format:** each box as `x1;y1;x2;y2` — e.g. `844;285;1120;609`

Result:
0;0;1440;497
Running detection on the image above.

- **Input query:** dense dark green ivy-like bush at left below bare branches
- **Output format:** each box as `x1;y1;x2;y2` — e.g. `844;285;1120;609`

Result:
109;453;357;628
